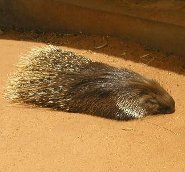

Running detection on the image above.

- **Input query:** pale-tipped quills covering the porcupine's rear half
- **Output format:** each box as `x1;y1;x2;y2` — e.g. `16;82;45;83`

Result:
6;45;90;109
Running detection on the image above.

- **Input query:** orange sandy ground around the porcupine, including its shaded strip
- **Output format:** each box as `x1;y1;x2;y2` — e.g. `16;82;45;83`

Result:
0;33;185;172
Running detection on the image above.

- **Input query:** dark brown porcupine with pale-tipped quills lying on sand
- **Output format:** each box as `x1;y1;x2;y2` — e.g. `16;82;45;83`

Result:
6;45;175;120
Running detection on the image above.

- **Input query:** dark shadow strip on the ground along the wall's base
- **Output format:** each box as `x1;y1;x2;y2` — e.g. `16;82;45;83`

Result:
0;31;185;75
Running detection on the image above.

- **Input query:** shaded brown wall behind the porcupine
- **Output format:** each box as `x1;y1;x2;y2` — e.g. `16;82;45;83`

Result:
0;0;185;56
